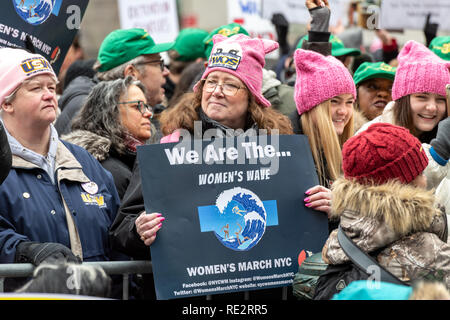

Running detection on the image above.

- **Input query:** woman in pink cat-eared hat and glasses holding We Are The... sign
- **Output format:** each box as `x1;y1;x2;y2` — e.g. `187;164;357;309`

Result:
111;34;292;297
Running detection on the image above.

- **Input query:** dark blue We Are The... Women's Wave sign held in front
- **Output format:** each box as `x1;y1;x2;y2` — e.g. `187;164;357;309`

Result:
138;135;328;299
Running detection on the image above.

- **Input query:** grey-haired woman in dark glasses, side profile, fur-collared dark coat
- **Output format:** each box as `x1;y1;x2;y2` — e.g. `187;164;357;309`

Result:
61;77;154;199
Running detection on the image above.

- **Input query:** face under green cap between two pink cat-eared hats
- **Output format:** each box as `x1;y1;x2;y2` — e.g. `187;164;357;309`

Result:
357;78;393;120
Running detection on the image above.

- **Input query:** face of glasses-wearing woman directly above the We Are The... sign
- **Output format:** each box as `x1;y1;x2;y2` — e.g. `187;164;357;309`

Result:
201;71;249;129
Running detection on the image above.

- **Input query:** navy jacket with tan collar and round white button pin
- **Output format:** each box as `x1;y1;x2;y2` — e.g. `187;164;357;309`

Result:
0;141;120;263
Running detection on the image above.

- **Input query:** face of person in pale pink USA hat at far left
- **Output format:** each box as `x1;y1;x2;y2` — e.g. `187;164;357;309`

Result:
3;74;58;128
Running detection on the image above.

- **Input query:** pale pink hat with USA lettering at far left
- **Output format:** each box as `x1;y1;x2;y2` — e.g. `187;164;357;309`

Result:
0;48;56;105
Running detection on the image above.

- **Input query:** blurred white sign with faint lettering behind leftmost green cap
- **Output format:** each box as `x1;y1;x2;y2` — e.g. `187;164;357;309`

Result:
118;0;179;43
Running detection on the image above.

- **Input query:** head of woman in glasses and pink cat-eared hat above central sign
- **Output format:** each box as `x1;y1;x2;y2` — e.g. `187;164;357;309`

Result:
160;34;292;142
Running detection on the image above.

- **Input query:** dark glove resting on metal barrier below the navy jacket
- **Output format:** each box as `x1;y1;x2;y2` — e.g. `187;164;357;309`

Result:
14;241;81;266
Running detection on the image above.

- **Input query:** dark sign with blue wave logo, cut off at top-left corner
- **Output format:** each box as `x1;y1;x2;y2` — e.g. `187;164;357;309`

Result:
0;0;89;74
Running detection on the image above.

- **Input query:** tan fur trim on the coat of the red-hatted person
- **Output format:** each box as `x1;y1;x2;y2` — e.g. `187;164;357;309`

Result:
330;177;441;234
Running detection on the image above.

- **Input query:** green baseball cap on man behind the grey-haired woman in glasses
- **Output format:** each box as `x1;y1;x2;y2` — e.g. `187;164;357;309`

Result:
97;28;175;72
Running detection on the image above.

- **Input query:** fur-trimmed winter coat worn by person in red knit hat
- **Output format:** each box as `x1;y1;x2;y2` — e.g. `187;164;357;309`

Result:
322;178;450;288
